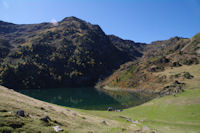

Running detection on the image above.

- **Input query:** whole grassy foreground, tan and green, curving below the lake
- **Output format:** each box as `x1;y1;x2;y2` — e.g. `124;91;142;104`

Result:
0;65;200;133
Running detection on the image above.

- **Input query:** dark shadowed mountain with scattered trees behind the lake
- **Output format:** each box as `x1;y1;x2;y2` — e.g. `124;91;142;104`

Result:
0;17;146;89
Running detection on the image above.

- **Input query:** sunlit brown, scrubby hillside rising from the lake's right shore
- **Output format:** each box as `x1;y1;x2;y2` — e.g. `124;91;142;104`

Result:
98;34;200;93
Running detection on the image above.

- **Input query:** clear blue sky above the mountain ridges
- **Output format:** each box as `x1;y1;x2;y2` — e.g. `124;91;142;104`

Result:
0;0;200;43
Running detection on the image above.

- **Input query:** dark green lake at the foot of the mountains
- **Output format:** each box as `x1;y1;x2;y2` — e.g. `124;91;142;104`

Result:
17;88;146;110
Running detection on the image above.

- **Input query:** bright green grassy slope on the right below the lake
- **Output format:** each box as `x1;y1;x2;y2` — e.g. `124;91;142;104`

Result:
75;65;200;133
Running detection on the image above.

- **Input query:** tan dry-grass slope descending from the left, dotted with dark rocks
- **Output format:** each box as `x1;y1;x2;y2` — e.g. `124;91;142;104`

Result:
0;86;141;133
